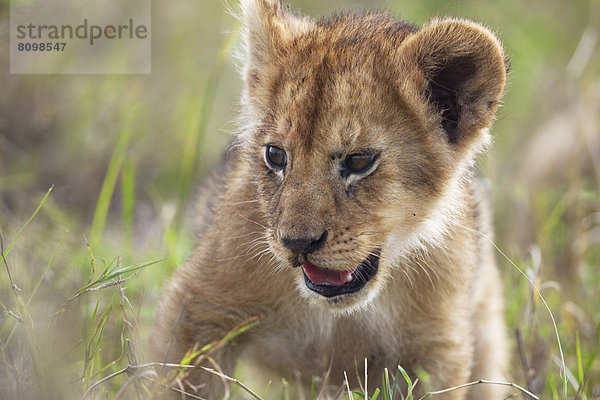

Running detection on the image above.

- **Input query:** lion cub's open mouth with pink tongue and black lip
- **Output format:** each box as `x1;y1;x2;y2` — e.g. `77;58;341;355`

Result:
302;252;379;297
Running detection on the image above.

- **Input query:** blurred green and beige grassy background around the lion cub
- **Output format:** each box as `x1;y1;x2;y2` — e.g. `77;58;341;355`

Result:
0;0;600;399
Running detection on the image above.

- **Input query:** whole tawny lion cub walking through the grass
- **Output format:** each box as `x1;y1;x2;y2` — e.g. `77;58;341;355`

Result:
154;0;507;399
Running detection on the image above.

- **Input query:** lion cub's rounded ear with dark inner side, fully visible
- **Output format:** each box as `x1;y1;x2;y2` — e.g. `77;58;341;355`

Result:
400;19;507;149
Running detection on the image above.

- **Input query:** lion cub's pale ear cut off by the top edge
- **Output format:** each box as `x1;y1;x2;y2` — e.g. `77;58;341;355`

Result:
240;0;313;89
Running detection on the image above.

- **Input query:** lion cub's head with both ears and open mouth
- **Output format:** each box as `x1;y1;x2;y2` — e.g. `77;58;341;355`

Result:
238;0;506;311
